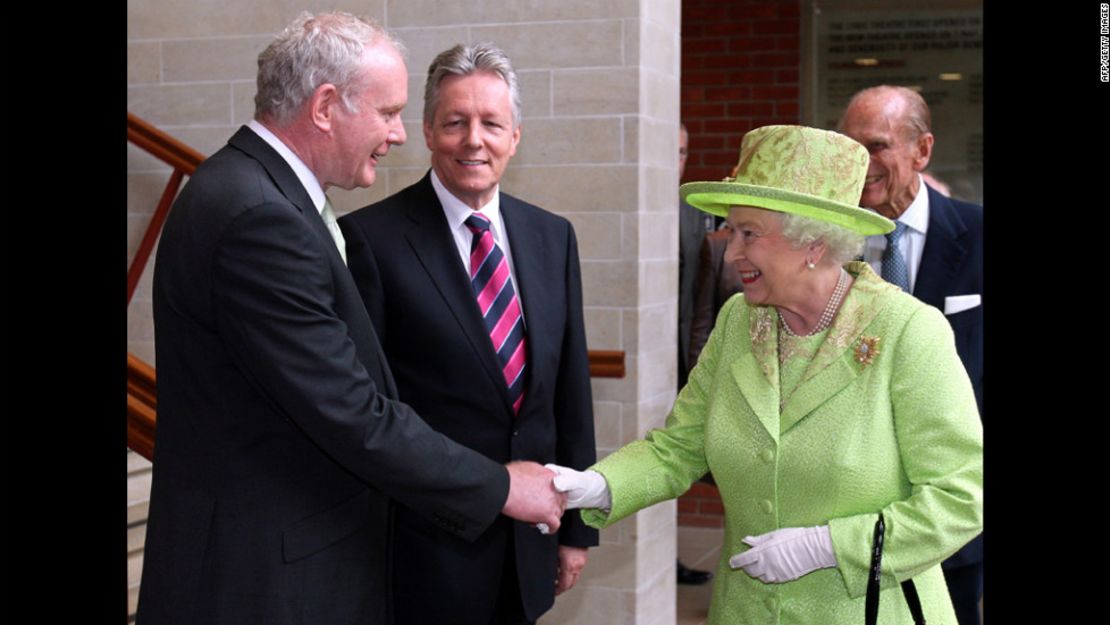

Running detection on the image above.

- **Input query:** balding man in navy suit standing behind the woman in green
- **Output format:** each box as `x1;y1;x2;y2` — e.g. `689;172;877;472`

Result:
840;85;982;625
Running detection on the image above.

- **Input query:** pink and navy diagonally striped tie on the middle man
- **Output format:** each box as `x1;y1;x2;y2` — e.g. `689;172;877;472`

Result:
466;213;527;414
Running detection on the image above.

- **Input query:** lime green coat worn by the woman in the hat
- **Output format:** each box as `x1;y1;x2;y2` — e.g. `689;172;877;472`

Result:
583;263;982;625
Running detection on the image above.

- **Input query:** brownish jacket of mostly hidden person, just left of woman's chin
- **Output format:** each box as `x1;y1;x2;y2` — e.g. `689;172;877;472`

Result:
687;229;744;369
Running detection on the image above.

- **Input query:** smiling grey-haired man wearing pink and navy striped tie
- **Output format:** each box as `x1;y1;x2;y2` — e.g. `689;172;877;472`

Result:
340;43;597;625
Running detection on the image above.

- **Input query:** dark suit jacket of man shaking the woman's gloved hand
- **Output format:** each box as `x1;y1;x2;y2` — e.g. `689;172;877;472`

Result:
139;128;508;625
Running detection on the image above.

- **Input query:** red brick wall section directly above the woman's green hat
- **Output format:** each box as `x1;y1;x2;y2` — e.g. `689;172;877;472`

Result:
682;0;801;182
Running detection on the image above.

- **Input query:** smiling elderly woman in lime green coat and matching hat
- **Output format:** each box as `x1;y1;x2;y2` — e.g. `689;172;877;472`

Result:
549;125;982;625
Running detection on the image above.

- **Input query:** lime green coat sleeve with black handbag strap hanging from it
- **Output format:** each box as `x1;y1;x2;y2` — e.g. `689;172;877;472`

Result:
829;306;982;597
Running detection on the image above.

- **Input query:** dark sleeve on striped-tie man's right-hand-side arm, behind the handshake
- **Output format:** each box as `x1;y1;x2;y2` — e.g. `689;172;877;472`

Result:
555;223;598;547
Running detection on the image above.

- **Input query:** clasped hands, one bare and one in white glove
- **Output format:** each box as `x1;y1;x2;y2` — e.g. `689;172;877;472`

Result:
502;462;609;534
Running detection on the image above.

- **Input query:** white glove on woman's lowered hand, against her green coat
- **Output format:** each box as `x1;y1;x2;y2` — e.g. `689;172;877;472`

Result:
728;525;836;584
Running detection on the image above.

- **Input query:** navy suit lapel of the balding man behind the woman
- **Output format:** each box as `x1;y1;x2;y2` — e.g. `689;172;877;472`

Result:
914;187;967;310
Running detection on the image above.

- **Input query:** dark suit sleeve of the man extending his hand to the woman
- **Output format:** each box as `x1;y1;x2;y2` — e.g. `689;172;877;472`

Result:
211;203;508;540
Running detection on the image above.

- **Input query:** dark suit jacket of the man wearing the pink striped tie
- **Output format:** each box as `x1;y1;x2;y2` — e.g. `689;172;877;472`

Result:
340;175;597;625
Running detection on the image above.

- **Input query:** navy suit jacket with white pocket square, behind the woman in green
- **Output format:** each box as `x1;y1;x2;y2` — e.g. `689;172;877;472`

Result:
914;187;983;568
